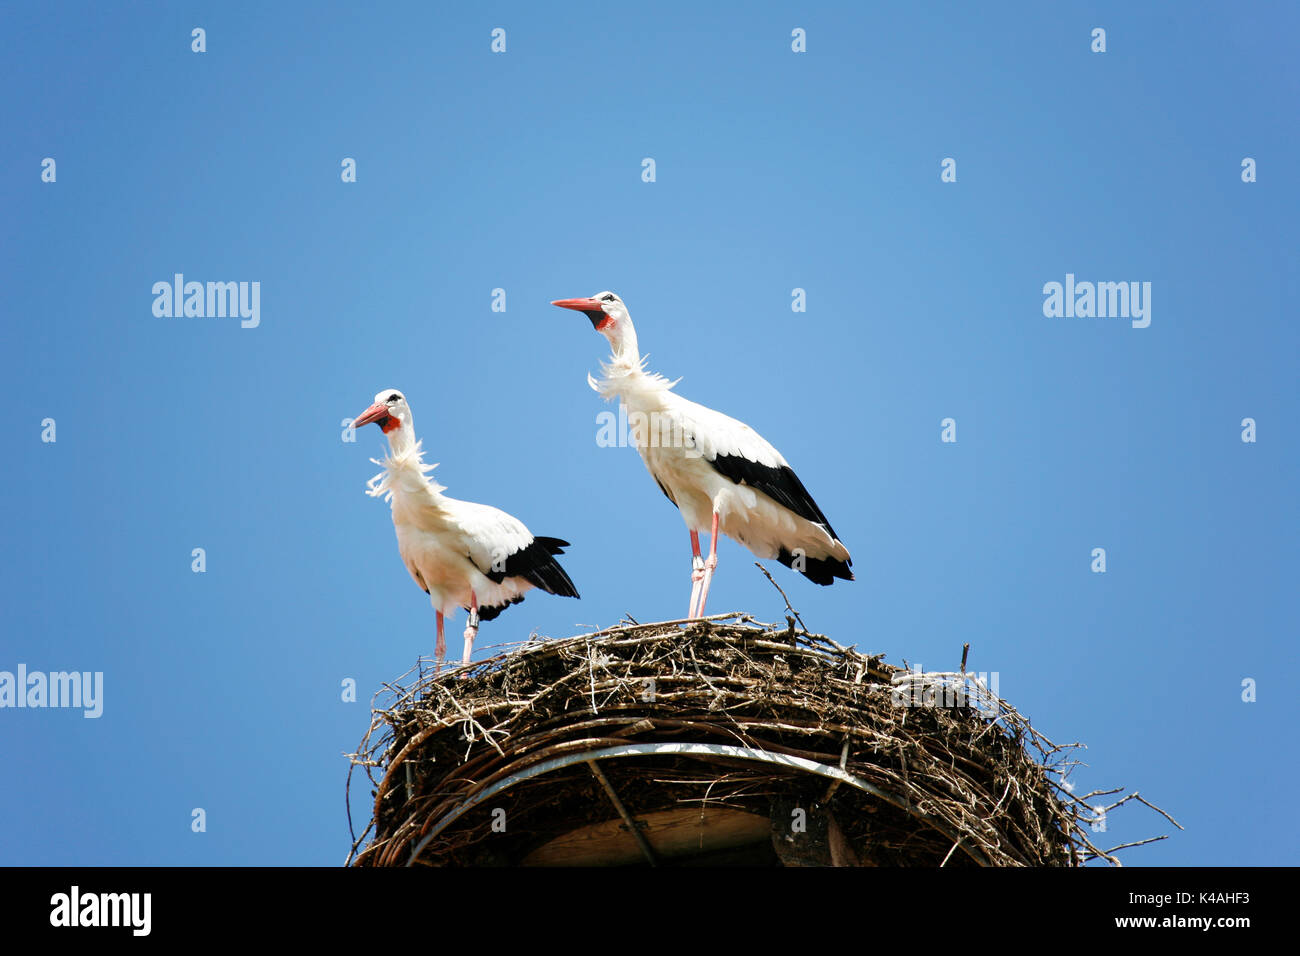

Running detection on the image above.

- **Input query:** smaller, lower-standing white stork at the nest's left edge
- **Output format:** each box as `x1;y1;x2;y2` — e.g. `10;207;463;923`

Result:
352;389;577;671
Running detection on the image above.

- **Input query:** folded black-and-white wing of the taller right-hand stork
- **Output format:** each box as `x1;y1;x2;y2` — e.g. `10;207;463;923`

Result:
673;395;840;541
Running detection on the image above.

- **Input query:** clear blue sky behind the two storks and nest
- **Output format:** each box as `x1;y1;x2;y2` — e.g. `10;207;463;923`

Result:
0;3;1300;865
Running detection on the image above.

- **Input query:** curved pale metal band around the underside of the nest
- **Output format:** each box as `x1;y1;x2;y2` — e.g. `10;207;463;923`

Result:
406;744;988;866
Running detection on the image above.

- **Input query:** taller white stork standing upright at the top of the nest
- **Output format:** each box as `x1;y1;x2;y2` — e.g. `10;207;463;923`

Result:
551;293;853;618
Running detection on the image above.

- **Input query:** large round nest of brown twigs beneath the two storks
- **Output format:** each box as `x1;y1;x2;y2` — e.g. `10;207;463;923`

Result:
348;614;1160;866
